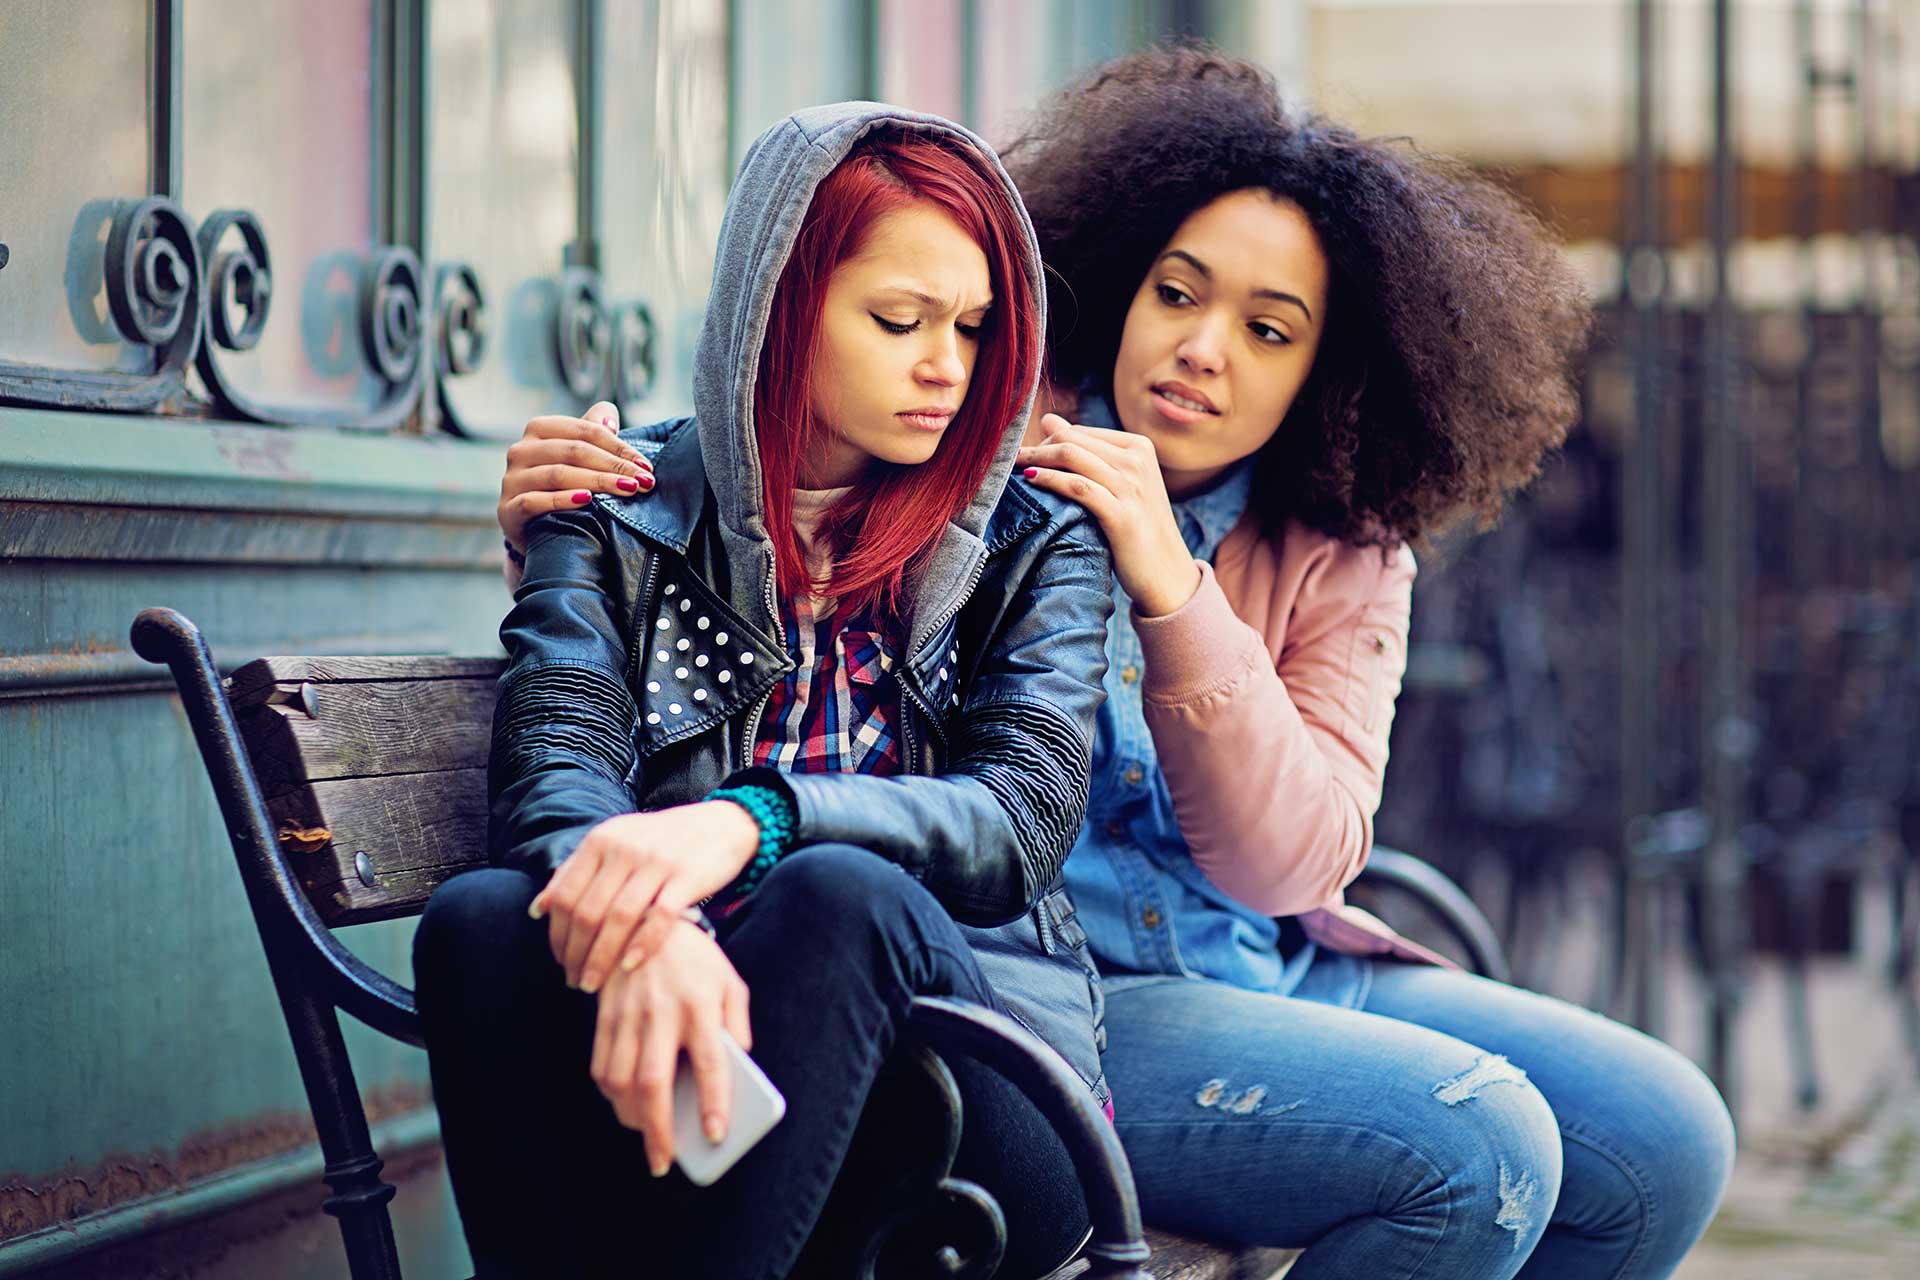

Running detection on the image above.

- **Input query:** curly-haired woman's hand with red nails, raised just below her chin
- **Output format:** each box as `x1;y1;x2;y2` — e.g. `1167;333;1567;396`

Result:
1014;413;1200;618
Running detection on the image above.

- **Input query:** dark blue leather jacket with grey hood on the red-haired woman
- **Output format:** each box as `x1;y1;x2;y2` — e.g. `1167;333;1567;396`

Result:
488;104;1112;1102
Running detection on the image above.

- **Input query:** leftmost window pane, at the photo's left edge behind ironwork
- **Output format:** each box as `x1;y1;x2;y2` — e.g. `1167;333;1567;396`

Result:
0;0;150;372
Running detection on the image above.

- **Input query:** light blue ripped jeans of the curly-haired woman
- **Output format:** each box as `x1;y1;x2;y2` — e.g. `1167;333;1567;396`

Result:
1104;967;1734;1280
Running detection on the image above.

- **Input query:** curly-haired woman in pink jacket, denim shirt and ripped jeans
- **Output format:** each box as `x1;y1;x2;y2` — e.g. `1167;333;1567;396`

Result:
487;48;1734;1280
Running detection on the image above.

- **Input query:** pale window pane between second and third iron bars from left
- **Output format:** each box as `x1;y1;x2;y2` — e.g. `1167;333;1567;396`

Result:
428;0;579;436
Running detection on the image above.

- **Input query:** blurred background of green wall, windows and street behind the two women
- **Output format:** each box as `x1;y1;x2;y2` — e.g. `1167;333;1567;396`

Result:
0;0;1920;1280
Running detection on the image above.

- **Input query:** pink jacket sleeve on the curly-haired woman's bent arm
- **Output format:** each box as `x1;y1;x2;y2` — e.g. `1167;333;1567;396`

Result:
1135;549;1413;915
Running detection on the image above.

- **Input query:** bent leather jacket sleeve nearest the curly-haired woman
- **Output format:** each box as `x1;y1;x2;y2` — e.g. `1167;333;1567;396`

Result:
730;516;1114;925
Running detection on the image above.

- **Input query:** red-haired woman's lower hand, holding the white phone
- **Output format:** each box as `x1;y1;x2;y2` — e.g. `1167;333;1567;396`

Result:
589;921;753;1176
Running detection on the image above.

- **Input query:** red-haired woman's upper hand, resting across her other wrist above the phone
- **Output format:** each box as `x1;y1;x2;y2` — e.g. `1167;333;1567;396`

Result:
530;800;760;992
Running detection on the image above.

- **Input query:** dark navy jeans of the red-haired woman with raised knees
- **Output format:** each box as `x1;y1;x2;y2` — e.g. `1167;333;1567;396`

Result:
413;844;1087;1280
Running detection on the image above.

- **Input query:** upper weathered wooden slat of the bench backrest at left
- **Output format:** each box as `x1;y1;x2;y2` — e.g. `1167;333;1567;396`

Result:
240;677;495;796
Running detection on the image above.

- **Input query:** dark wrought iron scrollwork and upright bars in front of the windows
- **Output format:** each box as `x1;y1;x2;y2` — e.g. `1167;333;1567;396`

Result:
0;0;659;436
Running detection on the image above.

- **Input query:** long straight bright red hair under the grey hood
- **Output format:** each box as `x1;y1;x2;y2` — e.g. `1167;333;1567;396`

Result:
753;132;1041;616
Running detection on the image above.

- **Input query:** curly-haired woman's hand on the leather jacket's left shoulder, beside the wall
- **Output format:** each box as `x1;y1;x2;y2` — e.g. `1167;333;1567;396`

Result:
495;401;653;551
